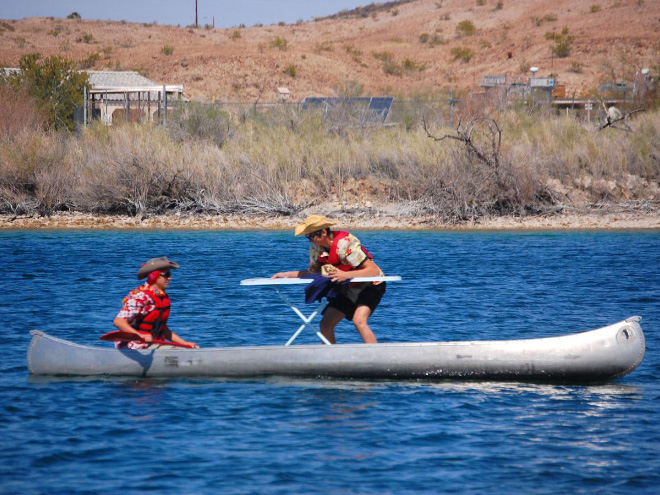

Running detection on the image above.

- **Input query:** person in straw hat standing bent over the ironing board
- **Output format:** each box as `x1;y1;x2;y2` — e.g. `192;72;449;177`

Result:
272;215;385;344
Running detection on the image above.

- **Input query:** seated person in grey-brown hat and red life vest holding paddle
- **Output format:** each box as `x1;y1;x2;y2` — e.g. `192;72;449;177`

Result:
114;256;198;349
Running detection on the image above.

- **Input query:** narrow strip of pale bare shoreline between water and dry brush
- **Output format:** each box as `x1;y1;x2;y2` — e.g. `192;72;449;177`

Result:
0;207;660;231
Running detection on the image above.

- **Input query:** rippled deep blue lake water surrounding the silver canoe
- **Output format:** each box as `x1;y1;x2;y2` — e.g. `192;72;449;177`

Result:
0;231;660;495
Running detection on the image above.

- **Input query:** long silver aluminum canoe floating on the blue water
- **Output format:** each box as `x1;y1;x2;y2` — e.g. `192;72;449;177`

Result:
28;317;645;382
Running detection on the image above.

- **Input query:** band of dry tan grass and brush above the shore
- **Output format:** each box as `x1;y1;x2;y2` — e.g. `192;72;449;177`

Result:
0;94;660;222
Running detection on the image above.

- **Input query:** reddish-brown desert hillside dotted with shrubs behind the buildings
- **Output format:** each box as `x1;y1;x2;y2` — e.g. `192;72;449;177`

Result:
0;0;660;101
